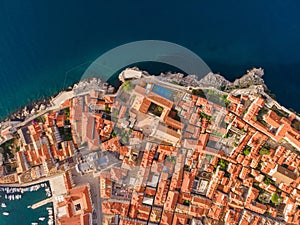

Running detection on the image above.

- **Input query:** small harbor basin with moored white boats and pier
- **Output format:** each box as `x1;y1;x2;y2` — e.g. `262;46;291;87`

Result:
0;182;54;225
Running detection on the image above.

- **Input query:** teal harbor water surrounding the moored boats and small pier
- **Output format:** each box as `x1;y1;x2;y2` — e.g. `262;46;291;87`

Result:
0;183;53;225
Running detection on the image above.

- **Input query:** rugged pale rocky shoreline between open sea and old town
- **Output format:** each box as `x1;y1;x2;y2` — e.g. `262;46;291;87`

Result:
1;68;288;125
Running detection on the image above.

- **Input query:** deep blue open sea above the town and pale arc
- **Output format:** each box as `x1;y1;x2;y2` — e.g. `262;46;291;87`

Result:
0;0;300;117
